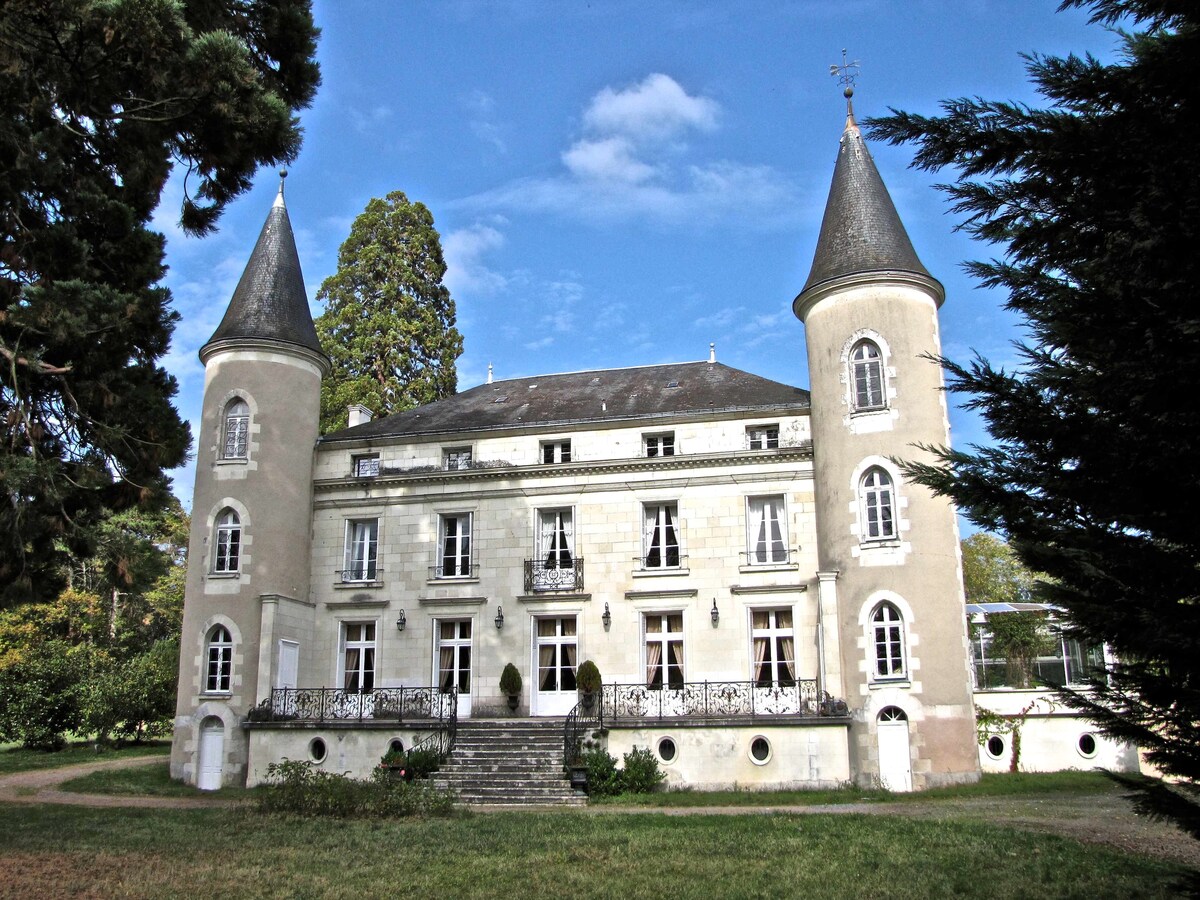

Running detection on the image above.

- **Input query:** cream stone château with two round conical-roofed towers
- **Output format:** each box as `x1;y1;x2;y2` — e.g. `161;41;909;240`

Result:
172;100;980;791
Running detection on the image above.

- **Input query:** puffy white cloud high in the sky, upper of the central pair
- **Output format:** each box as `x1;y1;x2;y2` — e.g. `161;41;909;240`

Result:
583;72;720;140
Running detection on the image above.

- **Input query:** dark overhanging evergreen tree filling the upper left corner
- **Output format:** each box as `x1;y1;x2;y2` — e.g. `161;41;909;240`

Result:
0;0;319;605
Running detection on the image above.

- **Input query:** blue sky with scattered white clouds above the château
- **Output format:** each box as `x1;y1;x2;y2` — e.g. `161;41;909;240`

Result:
156;0;1116;503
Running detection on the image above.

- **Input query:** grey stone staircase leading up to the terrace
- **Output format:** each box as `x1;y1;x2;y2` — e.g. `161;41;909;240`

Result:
433;719;587;806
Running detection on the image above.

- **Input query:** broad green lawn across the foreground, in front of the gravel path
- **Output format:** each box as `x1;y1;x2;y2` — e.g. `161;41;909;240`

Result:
0;805;1183;900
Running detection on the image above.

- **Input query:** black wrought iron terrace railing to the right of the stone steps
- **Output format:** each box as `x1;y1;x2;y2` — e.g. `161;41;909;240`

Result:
600;678;848;725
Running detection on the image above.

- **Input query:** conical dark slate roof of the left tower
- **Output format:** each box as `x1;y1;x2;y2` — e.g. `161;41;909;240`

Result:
200;173;324;359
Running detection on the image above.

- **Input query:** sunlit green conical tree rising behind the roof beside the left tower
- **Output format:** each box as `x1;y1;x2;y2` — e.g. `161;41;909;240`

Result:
316;191;462;432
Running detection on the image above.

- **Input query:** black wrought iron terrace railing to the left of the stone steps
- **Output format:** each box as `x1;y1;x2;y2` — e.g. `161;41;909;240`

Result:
247;688;458;725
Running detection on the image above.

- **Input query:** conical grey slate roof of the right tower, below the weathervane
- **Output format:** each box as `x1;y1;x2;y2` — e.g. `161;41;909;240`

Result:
800;114;932;295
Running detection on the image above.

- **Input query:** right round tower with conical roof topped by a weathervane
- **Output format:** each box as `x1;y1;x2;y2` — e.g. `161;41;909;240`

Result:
793;100;979;790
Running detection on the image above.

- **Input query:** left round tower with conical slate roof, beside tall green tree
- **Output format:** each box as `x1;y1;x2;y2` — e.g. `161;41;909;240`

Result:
170;181;329;788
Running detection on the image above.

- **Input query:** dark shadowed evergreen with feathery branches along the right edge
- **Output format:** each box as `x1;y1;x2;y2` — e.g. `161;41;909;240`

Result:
871;0;1200;830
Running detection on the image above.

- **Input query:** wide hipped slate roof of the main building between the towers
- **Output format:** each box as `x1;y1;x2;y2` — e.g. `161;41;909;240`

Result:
322;361;809;443
